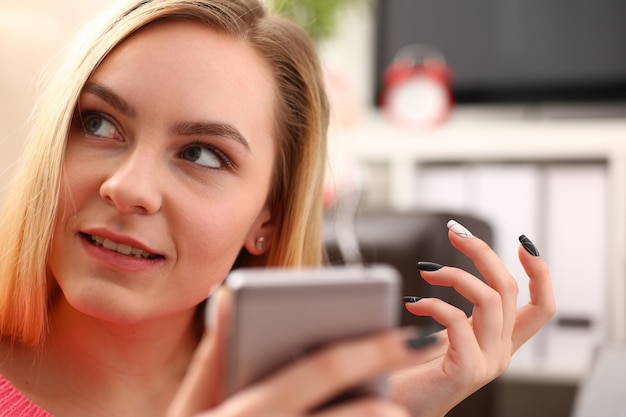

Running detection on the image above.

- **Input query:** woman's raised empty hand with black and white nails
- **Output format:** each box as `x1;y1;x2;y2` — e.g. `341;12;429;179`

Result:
391;221;555;416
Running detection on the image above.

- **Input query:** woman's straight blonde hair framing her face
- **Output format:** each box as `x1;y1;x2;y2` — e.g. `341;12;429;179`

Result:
0;0;329;345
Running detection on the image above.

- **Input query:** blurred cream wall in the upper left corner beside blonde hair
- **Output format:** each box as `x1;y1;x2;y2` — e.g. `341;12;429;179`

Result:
0;0;111;196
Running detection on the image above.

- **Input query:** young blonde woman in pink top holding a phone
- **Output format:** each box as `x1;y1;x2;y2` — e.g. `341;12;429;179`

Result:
0;0;554;417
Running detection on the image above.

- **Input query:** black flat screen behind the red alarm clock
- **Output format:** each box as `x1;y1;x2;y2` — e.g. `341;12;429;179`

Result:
375;0;626;103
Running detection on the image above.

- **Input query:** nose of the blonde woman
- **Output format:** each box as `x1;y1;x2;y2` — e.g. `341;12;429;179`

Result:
100;150;163;214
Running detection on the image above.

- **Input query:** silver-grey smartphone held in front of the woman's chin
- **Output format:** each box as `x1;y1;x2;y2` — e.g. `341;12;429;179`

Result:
217;265;401;403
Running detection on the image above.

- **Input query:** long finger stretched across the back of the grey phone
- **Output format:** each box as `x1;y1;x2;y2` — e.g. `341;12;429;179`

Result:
222;329;432;416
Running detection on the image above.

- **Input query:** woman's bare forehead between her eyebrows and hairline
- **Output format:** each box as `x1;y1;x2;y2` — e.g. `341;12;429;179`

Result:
90;20;276;145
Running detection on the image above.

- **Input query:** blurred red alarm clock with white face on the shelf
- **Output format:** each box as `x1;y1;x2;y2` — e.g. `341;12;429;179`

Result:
381;44;453;127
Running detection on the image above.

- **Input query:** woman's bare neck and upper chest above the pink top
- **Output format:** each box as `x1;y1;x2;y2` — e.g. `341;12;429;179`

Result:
1;297;198;416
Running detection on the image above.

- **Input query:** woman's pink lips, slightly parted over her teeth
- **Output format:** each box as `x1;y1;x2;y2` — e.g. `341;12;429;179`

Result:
78;229;164;272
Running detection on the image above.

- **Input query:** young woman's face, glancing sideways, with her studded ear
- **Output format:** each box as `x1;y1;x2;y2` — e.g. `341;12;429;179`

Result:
49;21;275;323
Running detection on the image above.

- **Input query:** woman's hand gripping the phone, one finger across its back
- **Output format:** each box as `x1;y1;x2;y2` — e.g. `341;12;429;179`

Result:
167;289;436;417
